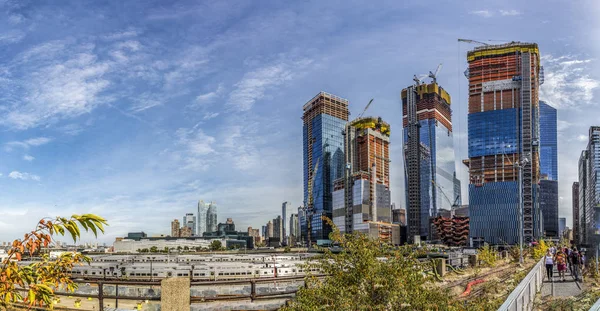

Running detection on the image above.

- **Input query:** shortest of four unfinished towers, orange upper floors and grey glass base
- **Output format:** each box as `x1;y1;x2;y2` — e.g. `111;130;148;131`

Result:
332;117;392;240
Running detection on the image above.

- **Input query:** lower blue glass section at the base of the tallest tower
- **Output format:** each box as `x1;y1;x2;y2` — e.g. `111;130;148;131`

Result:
469;181;519;247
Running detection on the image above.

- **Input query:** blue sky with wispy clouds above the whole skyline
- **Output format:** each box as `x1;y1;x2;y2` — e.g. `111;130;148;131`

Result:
0;0;600;243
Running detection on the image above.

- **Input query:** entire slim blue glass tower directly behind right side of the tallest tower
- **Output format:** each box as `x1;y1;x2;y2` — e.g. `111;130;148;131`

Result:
539;101;559;238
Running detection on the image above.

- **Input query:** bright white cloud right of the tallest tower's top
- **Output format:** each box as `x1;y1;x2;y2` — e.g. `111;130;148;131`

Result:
540;55;600;109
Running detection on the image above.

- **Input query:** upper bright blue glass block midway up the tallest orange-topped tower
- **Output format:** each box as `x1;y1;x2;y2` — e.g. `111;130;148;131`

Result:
468;108;520;158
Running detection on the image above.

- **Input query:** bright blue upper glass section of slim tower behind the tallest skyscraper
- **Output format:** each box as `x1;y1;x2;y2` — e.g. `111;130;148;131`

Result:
540;101;558;180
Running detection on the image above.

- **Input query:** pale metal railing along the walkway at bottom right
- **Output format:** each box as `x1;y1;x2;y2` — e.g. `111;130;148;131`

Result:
498;259;546;311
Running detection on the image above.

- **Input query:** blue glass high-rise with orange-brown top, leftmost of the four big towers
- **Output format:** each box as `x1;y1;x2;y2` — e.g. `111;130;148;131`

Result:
302;92;350;243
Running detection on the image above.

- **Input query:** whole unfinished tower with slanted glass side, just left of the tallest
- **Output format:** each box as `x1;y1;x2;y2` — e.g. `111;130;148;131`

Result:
401;81;460;241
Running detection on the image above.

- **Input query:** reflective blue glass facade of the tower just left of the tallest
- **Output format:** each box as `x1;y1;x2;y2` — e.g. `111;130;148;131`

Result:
404;119;460;236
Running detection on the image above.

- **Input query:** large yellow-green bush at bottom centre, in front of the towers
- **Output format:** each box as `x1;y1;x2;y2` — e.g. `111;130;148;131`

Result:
282;218;461;311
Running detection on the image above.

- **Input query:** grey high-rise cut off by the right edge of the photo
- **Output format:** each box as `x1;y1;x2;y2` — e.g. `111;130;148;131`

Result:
578;126;600;245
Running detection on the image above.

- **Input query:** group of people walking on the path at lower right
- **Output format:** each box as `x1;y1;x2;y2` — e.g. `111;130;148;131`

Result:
544;246;585;282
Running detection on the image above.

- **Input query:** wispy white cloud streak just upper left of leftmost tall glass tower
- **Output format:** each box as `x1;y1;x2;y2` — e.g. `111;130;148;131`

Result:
227;59;312;111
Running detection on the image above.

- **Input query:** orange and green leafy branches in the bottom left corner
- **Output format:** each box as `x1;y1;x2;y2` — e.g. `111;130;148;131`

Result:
0;214;107;309
